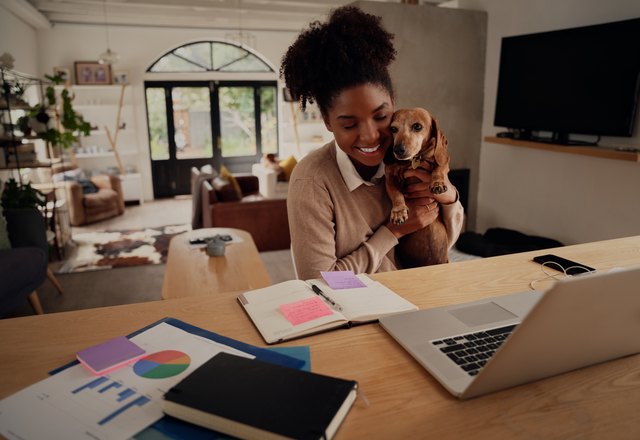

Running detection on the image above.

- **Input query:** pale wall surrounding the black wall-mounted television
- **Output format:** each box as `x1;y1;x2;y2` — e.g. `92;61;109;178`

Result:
459;0;640;244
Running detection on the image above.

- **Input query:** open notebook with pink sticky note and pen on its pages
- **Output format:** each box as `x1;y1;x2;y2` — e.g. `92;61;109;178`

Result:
238;274;418;344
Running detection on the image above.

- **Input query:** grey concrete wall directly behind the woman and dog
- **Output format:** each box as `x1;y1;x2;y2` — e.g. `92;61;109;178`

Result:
356;2;487;229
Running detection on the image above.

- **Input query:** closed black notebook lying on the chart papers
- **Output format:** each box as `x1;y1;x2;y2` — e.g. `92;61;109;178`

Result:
163;353;357;439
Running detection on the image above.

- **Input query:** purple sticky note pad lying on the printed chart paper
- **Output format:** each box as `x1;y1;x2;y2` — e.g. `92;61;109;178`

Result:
76;336;146;374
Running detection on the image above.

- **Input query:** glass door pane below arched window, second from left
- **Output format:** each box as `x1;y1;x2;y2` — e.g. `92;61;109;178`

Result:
171;87;213;159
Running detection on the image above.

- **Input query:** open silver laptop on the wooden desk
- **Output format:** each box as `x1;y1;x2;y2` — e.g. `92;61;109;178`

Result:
380;268;640;399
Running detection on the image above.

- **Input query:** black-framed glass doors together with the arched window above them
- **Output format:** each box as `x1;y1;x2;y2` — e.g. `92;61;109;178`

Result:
145;41;278;197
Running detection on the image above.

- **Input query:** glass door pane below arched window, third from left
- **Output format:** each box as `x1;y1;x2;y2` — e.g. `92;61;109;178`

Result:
218;87;258;157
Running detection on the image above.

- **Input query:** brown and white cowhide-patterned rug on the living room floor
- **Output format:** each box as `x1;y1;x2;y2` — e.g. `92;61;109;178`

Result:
57;224;191;273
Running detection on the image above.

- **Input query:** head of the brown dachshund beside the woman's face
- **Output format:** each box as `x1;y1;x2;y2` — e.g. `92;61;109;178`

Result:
391;108;446;167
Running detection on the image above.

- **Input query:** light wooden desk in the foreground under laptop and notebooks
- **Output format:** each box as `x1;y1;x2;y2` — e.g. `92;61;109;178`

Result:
0;236;640;439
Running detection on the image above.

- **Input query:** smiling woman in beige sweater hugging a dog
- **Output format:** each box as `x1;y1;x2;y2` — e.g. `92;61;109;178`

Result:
280;7;463;279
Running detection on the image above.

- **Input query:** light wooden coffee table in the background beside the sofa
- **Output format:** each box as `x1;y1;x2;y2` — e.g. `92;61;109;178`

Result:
162;228;271;299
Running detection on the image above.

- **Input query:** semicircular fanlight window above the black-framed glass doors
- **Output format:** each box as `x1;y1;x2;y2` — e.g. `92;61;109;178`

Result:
147;41;273;73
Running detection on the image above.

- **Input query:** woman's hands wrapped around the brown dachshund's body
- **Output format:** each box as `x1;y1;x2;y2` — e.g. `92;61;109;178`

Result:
387;168;458;238
